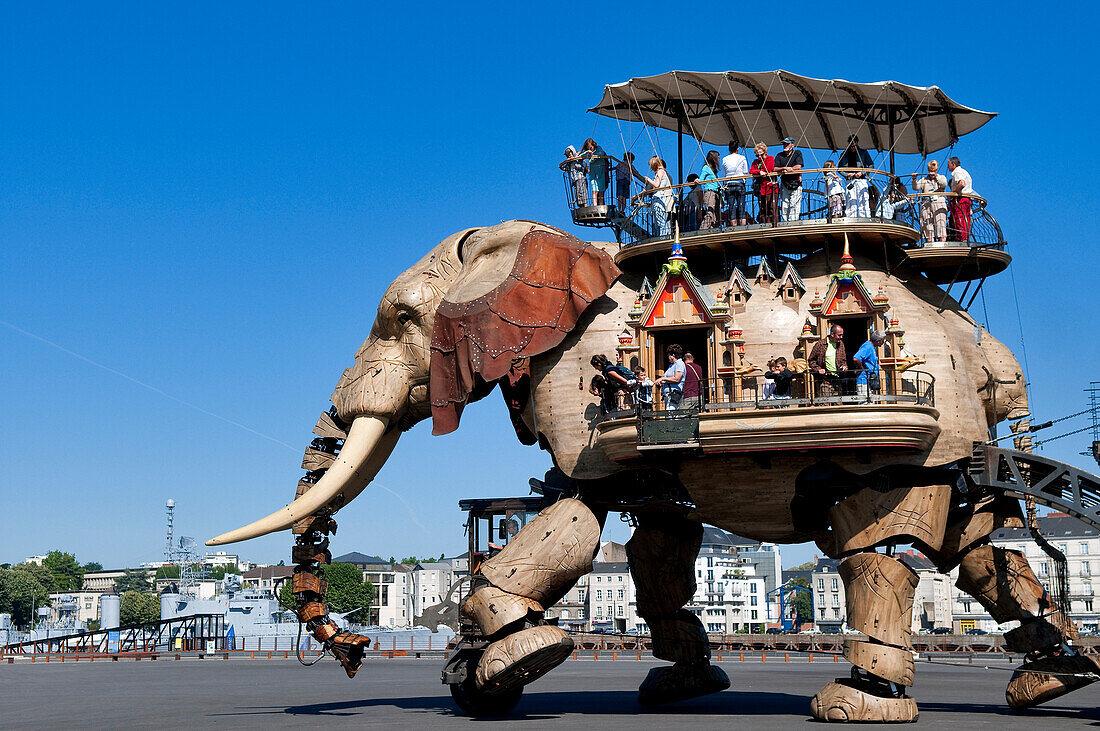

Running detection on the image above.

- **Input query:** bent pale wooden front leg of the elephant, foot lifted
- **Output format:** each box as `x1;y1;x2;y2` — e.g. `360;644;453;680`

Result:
461;498;601;698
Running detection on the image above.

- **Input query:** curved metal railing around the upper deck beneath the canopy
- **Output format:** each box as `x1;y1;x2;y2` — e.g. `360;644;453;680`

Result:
560;156;1004;248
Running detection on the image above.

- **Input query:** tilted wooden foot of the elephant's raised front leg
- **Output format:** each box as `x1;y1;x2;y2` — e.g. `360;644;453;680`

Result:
474;624;573;695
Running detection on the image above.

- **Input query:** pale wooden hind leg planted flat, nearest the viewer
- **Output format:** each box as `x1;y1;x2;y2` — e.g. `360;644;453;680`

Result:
810;485;952;723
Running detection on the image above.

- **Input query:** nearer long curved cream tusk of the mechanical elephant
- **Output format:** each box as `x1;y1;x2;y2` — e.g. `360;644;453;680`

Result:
206;417;400;545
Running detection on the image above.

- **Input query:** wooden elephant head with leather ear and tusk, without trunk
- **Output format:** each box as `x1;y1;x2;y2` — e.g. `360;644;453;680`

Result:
207;221;620;545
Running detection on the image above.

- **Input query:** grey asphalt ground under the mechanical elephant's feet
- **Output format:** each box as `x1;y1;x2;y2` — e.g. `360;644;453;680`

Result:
0;657;1100;731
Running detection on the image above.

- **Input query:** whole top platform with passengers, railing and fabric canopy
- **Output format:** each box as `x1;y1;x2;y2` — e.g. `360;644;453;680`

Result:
559;70;1011;285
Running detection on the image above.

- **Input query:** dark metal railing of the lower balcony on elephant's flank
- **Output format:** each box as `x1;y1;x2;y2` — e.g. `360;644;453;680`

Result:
608;370;936;418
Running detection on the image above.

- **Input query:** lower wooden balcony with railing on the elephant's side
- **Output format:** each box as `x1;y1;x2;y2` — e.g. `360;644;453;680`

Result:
596;370;939;462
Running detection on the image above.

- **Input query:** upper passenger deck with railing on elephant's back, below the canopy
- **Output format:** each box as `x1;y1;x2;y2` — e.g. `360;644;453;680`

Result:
560;156;1012;285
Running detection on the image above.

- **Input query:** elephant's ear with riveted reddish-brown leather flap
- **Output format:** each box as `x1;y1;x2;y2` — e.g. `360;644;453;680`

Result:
429;221;622;434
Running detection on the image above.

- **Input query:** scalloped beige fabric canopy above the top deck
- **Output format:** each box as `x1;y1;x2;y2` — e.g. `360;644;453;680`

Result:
589;70;997;155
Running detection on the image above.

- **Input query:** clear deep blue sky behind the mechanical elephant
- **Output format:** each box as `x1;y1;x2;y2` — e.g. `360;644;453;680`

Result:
0;3;1100;566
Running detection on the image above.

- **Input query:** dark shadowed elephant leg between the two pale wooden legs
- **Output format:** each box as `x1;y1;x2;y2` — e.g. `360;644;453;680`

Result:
626;513;729;706
